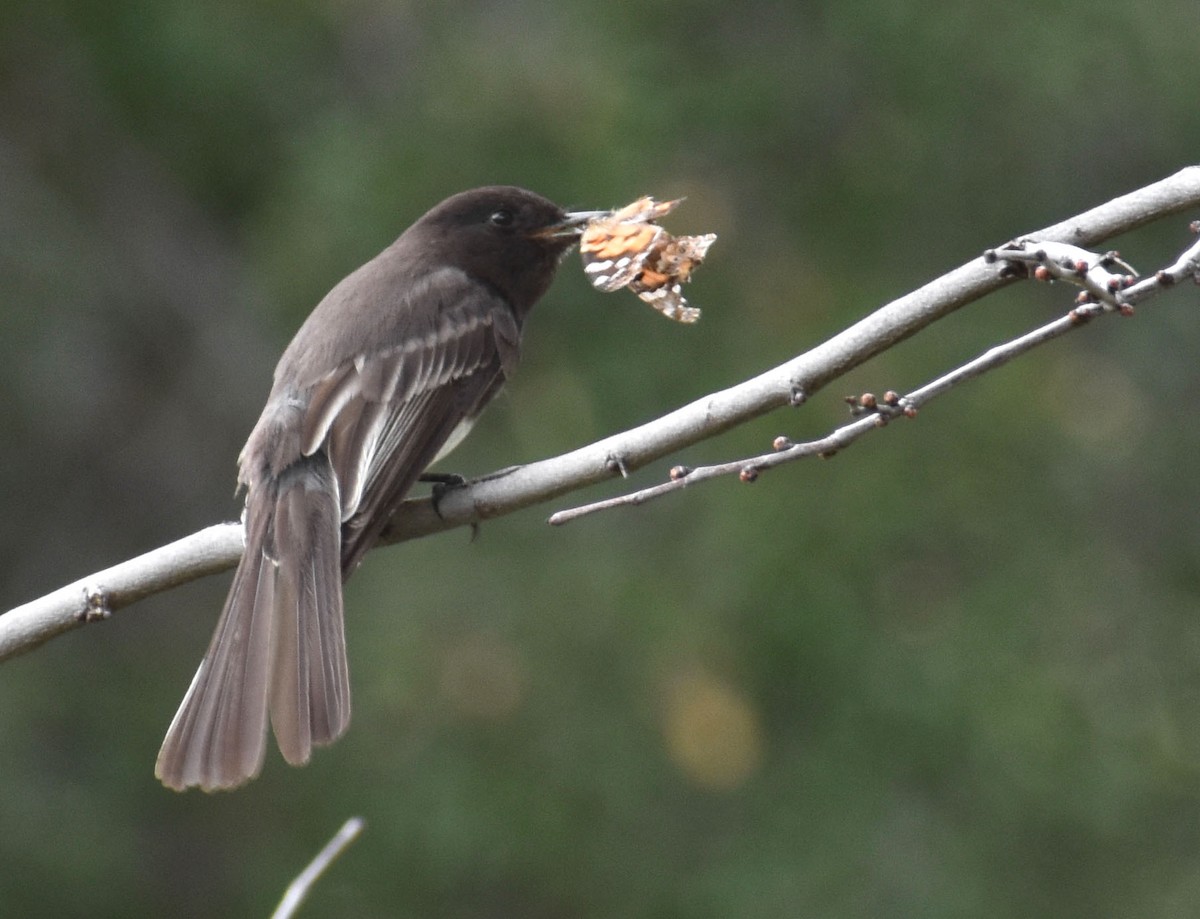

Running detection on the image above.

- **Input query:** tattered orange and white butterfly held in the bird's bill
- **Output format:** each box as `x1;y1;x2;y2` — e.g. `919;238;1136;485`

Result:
580;197;716;323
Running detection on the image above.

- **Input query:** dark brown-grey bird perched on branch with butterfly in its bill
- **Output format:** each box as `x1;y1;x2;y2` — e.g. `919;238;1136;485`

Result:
155;186;598;791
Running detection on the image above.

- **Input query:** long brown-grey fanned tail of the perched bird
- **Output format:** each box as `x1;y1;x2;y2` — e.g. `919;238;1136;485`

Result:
155;454;350;791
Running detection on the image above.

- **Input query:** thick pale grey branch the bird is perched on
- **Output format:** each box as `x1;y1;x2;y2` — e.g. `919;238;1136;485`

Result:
0;166;1200;661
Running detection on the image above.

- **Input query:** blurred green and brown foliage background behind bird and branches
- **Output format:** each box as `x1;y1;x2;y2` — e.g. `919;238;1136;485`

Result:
0;0;1200;919
